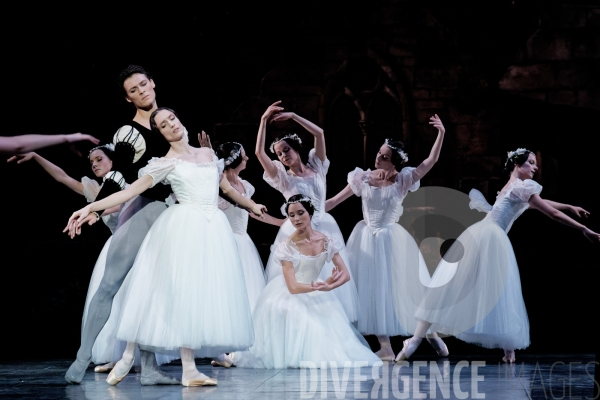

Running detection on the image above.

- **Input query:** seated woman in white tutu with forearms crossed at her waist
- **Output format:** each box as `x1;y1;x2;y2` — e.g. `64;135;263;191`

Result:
230;194;379;368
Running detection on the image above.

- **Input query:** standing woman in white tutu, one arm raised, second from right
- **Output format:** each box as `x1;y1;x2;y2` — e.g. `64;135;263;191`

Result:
326;114;448;361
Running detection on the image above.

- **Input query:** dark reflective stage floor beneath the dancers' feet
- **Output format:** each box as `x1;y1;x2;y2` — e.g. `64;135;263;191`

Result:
0;353;595;400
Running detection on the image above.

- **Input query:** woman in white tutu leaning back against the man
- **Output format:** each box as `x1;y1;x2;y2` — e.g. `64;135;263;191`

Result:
69;108;264;386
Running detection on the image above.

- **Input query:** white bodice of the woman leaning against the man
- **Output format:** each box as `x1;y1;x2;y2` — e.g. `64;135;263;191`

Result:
139;155;223;219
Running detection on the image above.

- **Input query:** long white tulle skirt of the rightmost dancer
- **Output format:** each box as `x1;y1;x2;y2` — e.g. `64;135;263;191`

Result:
416;215;530;350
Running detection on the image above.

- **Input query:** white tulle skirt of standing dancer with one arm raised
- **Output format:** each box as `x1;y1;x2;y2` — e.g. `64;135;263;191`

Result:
346;221;429;336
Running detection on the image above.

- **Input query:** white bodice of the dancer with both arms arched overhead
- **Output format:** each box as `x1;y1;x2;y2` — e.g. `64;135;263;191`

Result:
263;149;329;225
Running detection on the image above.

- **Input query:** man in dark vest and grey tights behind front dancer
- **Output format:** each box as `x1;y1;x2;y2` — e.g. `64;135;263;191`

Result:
65;65;180;385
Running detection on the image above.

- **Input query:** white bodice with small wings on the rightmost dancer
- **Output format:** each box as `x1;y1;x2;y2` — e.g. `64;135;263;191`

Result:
469;179;542;233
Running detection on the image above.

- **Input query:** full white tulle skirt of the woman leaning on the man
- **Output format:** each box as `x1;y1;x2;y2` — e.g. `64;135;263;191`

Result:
117;204;254;357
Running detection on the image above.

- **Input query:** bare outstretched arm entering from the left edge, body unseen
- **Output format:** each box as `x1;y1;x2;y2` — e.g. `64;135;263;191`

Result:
0;133;100;154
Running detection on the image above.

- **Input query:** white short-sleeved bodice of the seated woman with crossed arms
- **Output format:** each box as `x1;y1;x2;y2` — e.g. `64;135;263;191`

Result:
273;236;344;284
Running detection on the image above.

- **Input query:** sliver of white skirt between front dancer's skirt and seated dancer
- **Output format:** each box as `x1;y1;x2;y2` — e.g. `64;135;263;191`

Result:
234;232;266;310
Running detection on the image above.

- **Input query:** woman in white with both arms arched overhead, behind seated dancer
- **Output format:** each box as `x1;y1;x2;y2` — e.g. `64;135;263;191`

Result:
256;101;358;322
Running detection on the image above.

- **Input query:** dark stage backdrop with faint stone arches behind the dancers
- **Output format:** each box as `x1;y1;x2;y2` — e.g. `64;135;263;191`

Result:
0;1;600;360
